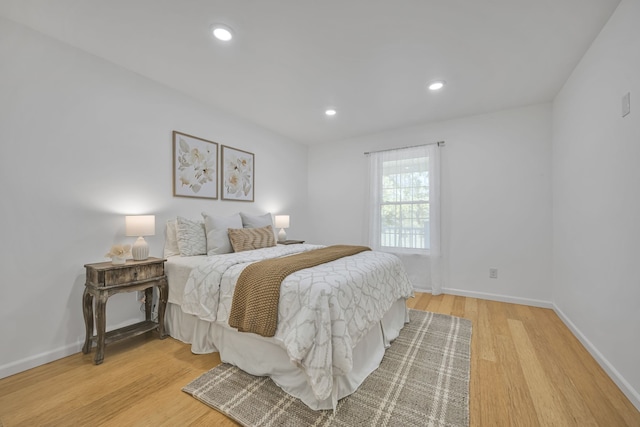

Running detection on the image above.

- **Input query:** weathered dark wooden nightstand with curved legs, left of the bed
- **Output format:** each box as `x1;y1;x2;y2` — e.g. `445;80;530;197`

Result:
82;258;169;365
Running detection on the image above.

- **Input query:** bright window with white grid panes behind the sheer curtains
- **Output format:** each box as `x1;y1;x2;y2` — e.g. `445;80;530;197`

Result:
369;145;437;254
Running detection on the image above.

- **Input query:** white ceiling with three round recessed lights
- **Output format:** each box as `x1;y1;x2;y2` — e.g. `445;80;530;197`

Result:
0;0;620;144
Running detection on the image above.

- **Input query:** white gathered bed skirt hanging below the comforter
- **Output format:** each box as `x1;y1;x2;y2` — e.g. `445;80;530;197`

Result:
165;298;409;410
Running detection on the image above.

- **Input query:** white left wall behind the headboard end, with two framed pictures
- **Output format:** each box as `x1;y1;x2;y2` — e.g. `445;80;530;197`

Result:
0;18;308;377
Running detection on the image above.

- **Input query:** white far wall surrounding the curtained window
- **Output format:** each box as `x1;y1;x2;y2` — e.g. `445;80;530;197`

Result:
302;104;551;306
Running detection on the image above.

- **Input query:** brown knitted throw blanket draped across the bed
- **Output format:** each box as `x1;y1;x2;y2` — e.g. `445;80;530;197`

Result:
229;245;371;337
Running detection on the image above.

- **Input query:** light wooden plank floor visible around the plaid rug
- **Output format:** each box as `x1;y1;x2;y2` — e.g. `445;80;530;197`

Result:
0;294;640;427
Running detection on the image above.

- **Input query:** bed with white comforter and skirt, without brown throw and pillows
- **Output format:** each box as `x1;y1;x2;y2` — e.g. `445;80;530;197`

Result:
165;214;413;410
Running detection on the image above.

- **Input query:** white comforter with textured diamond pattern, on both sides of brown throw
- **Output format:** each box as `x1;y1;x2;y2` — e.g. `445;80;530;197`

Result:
182;244;413;400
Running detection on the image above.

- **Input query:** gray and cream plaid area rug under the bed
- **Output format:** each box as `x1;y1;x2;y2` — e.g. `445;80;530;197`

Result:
183;310;471;427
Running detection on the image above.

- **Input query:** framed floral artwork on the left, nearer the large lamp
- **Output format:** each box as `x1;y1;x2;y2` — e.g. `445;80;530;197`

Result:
173;131;218;199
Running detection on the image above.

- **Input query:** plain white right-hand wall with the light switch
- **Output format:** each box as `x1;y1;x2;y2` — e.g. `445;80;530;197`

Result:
553;0;640;409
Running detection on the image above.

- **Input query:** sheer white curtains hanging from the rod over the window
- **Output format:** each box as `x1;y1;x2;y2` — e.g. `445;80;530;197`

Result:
367;144;442;295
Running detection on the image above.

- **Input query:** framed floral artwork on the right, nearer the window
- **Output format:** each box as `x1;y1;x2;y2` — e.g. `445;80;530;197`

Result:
222;145;254;202
